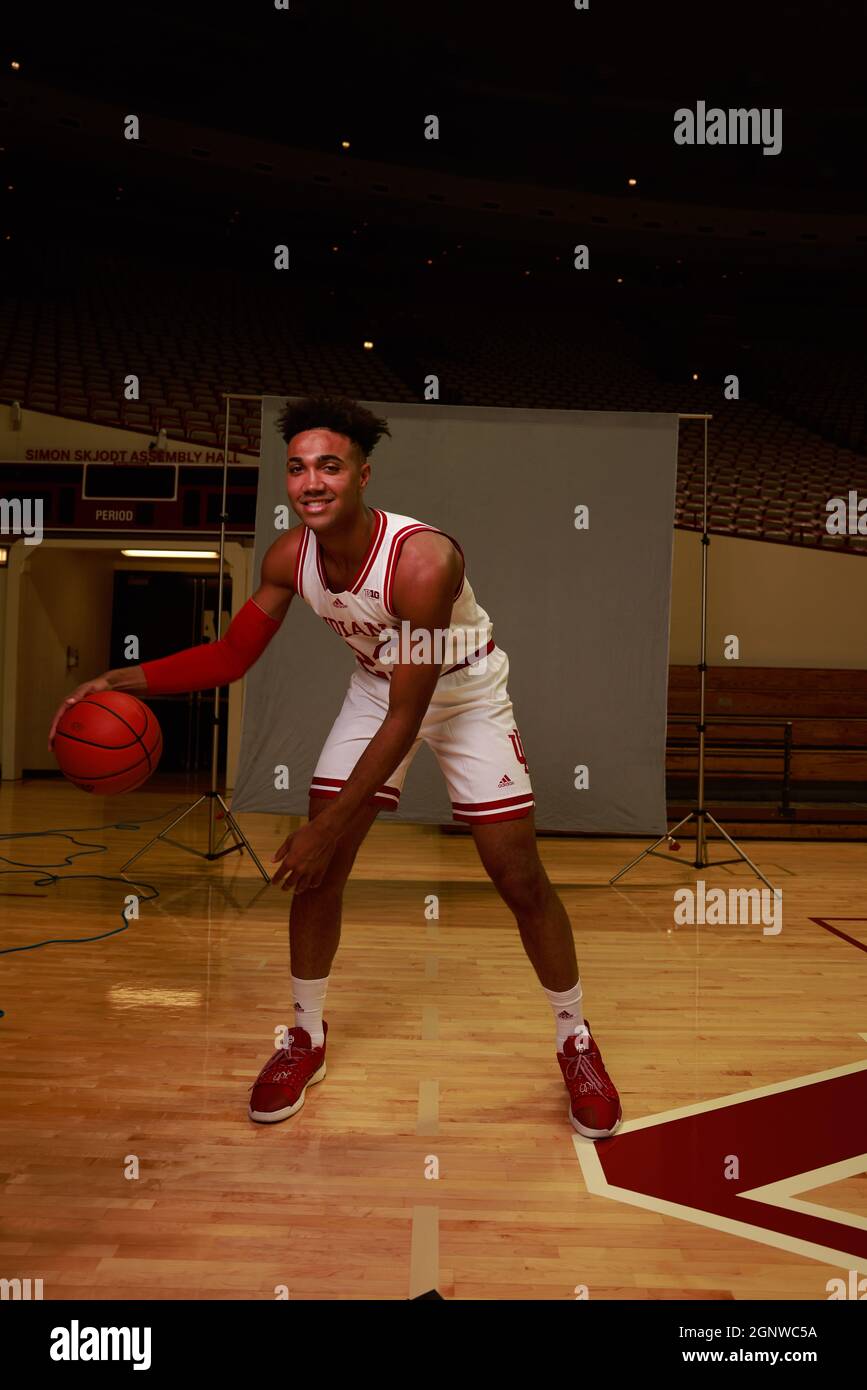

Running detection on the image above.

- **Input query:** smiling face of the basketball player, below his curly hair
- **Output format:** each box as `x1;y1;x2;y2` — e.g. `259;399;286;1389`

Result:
286;430;370;534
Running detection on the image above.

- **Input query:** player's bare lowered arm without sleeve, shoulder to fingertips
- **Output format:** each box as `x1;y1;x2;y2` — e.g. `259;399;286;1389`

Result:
272;531;463;891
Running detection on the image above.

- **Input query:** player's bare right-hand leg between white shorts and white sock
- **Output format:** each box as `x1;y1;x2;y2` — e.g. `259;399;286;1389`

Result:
471;812;578;992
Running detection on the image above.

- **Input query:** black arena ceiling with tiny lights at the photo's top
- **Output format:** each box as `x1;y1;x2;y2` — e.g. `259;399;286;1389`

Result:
0;0;867;353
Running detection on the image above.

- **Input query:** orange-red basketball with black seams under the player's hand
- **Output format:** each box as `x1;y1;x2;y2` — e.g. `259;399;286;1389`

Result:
54;691;163;796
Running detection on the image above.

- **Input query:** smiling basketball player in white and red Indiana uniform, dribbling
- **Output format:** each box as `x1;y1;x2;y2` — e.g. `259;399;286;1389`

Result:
49;396;621;1140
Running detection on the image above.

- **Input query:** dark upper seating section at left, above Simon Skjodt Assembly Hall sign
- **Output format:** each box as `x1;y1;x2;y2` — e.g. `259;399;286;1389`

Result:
0;263;411;453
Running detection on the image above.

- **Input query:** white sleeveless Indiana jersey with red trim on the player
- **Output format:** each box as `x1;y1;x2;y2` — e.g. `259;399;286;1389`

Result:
293;507;495;680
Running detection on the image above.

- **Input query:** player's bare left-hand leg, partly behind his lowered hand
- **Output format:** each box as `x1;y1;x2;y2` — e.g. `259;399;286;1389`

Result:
289;796;382;980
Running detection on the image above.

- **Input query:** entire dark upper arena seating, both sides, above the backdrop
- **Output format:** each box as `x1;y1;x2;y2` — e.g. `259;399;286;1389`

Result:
0;261;867;553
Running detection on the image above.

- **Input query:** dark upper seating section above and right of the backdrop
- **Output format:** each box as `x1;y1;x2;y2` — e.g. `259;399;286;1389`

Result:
419;312;867;555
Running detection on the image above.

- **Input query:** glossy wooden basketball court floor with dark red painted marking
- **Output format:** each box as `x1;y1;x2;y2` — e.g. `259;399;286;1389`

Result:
0;778;867;1300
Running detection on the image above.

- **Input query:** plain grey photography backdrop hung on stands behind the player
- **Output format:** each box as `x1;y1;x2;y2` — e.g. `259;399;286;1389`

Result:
232;396;678;835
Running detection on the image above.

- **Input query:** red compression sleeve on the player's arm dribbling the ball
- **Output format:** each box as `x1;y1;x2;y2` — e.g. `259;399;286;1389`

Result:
140;599;279;695
